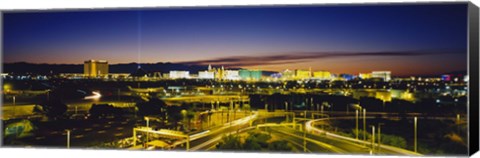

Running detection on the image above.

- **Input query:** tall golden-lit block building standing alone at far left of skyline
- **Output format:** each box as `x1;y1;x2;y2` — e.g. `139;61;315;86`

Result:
83;60;108;77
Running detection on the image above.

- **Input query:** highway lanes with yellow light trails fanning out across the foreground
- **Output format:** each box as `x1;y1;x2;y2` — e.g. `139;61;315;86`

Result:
187;110;428;156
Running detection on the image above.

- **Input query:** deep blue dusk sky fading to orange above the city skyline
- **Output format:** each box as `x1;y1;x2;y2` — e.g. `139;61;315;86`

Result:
3;3;467;75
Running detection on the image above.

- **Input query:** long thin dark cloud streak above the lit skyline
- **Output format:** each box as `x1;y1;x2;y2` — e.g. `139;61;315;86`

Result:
179;52;450;67
